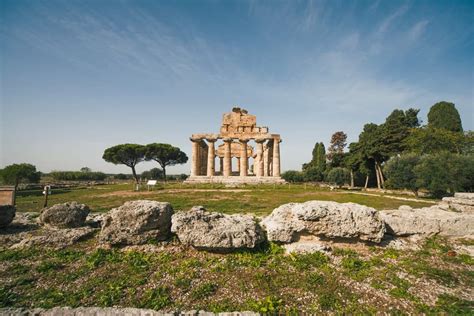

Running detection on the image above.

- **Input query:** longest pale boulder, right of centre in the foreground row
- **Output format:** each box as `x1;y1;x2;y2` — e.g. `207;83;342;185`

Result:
262;201;385;243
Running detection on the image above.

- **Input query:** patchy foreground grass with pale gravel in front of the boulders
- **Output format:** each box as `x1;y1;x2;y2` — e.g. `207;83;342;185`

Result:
0;239;474;315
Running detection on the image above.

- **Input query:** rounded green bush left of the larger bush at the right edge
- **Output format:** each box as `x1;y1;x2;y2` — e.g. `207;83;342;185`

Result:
384;153;420;196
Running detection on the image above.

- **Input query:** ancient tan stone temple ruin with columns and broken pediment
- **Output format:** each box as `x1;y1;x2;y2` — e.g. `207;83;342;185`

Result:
186;107;285;183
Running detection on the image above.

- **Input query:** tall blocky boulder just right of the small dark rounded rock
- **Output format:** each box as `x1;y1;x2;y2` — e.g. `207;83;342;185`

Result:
99;200;173;245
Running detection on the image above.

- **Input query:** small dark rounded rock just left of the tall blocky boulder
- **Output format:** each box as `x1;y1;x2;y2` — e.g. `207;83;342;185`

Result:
39;202;90;228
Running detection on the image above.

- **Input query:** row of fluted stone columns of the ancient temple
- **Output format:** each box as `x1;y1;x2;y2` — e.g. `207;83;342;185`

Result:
191;138;281;177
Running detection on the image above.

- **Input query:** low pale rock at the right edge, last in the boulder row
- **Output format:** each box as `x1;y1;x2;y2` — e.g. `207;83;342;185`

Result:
380;205;474;237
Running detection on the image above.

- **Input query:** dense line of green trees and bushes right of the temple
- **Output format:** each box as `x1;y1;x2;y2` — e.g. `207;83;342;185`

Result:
283;101;474;196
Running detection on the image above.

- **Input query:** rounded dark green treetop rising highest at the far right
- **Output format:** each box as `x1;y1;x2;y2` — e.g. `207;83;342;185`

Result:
428;101;463;133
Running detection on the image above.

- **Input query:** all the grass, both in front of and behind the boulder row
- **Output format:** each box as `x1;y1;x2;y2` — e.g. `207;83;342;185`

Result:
0;183;474;315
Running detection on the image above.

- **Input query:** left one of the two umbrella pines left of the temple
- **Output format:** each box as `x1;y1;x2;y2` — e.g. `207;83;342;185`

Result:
102;144;146;184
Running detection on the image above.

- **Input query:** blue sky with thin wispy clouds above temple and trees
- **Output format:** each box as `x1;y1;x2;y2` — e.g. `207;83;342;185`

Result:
0;0;474;173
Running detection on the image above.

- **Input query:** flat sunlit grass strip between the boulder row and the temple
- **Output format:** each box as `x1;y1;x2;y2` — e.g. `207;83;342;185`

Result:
17;183;431;215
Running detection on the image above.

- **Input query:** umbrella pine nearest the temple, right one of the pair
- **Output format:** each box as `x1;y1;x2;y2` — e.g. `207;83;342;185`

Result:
145;143;188;181
